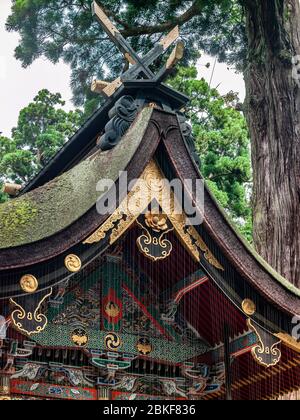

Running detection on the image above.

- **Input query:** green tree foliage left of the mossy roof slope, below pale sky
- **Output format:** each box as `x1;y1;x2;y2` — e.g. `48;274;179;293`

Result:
0;90;82;201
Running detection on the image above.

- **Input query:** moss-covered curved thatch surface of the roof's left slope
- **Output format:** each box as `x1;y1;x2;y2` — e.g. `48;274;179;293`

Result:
0;108;153;249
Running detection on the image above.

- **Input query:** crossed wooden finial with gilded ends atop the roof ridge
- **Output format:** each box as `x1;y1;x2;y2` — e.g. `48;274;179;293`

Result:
91;0;184;97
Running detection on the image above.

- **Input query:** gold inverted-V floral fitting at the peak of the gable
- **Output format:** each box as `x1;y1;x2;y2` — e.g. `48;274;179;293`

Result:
84;160;223;270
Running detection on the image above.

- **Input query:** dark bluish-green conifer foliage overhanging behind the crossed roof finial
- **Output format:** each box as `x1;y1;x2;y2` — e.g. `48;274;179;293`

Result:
7;0;247;108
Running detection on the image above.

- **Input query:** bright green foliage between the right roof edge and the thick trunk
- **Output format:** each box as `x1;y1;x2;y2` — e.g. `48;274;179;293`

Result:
170;67;252;240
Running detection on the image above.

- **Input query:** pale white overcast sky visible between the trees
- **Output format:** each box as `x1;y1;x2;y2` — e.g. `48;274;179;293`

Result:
0;0;245;136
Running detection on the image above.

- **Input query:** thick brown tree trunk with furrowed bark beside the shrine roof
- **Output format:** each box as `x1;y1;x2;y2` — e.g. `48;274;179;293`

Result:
243;0;300;287
